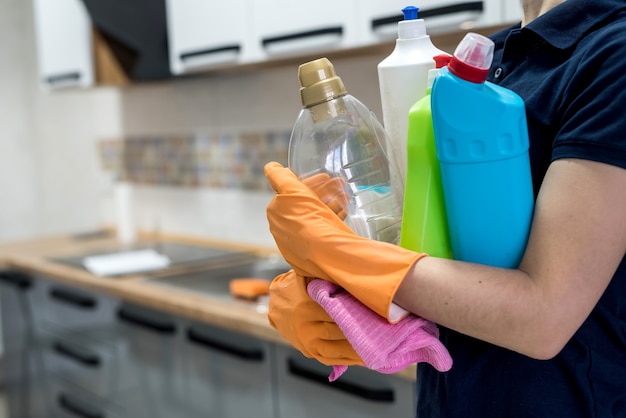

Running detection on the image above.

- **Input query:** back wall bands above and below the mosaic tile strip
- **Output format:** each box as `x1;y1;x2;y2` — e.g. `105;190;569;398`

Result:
114;57;388;246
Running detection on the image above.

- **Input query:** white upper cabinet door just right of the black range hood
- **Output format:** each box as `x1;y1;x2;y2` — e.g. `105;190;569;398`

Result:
165;0;252;74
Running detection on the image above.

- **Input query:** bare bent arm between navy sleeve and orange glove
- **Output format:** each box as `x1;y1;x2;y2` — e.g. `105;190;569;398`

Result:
394;159;626;359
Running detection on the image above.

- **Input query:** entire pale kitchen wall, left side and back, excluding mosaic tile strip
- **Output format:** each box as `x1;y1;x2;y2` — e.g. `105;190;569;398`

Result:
0;0;454;246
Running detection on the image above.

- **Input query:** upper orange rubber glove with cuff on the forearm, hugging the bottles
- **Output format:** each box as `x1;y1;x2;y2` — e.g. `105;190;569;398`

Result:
265;163;425;323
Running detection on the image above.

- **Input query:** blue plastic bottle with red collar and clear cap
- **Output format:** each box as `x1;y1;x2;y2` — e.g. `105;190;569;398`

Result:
431;33;534;268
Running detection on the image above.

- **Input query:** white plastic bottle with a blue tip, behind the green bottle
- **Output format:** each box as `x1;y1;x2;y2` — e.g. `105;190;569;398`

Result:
378;6;444;190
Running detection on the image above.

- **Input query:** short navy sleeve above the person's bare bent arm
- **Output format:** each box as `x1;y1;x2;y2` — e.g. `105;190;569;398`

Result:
552;19;626;168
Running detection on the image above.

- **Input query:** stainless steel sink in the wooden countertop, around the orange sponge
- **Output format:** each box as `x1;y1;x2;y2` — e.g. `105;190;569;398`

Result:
144;257;291;311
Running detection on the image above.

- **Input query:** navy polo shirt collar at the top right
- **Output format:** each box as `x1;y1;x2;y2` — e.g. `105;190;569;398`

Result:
523;0;626;49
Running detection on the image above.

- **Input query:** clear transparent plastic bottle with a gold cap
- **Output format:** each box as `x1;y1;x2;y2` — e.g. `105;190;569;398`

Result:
288;58;403;244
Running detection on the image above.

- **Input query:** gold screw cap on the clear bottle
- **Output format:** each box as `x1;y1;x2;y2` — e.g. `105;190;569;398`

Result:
298;58;347;107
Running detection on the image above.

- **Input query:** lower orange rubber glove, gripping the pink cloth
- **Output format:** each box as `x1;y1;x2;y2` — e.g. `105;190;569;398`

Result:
267;270;365;366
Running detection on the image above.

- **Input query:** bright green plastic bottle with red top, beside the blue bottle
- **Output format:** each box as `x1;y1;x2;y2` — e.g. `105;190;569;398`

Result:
400;55;452;258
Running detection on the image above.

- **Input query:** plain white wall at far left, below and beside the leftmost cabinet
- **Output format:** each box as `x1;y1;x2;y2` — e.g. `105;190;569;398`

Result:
0;0;121;241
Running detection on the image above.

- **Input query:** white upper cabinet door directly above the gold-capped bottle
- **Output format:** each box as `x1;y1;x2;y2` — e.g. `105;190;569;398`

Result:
250;0;360;58
